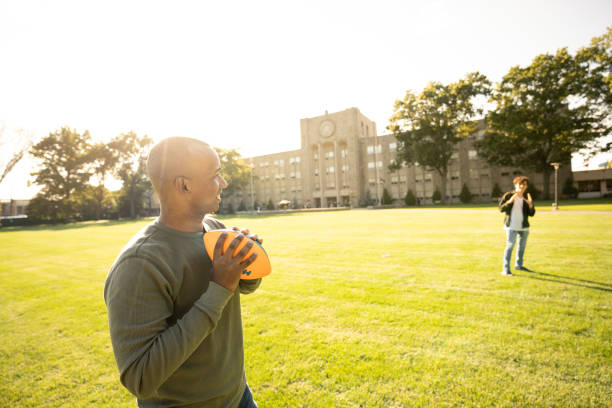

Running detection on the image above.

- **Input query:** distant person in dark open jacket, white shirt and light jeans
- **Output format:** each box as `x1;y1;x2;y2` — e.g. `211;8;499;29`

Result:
499;176;535;276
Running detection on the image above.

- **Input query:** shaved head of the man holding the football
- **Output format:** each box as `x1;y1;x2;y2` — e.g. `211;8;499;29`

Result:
147;137;227;217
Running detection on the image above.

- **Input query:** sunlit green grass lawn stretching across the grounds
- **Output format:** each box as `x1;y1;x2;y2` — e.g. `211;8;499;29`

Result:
0;207;612;408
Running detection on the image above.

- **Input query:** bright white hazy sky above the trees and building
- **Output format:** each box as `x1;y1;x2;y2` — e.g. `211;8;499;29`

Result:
0;0;612;198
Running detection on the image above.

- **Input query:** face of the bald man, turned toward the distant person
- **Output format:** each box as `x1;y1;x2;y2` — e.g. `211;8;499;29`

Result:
191;147;227;215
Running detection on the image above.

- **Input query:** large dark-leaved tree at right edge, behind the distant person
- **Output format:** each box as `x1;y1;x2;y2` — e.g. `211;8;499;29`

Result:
476;29;612;198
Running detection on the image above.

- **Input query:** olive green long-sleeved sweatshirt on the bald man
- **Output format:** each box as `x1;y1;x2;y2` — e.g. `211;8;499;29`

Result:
104;218;261;407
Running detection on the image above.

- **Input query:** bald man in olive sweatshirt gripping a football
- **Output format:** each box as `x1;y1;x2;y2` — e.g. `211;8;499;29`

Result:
104;137;261;408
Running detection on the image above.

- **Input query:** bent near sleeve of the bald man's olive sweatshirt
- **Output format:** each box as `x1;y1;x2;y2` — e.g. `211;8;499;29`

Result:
104;256;234;398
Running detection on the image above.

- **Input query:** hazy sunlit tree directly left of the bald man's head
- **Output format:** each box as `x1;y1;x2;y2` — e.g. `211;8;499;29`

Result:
109;131;153;218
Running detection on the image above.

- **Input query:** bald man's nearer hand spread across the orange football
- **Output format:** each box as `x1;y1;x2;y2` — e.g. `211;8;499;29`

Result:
210;232;257;292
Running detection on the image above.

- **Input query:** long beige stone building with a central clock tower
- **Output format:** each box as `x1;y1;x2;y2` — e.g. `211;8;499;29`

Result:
226;108;571;209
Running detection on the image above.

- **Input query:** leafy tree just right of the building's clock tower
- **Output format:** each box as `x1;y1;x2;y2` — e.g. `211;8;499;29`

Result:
388;72;490;204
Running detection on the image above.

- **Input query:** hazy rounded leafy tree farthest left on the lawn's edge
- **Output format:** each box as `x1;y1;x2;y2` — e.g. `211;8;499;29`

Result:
28;127;92;221
